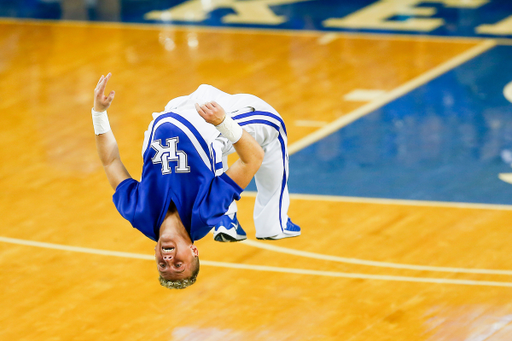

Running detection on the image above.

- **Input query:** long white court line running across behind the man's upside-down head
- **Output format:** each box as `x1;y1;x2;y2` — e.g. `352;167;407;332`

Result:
0;237;512;288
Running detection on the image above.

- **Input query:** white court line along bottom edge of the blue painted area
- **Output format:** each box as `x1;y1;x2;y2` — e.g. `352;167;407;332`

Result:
242;191;512;211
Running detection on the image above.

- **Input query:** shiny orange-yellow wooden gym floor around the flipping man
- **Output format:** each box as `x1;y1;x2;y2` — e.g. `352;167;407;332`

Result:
0;20;512;341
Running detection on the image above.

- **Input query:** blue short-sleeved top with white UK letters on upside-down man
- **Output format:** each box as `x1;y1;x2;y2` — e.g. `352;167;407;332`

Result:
113;113;243;241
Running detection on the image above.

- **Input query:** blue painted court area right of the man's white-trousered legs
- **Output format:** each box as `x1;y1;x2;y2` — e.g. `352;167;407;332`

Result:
289;46;512;204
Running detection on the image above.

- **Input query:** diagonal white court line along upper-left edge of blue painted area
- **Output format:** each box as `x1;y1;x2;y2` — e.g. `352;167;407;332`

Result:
288;39;497;155
